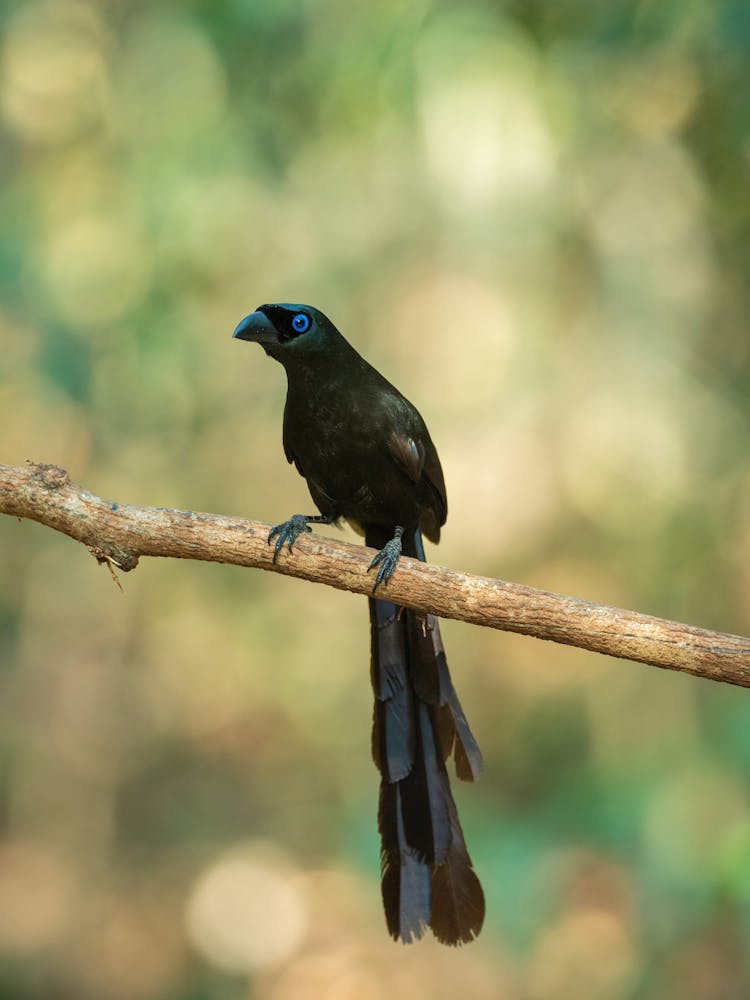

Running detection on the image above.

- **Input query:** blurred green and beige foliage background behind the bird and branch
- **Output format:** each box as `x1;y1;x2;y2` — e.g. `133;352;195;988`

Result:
0;0;750;1000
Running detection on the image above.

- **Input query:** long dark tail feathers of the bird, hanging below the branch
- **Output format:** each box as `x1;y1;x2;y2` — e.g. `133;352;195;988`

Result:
366;531;484;944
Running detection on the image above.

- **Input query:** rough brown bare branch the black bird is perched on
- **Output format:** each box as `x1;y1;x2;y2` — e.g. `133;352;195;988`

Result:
0;463;750;687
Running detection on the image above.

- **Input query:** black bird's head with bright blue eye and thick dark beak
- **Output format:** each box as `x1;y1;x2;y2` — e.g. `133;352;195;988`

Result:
232;302;341;367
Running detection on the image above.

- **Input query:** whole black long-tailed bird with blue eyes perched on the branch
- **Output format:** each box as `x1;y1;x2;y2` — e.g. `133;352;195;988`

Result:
234;304;484;944
